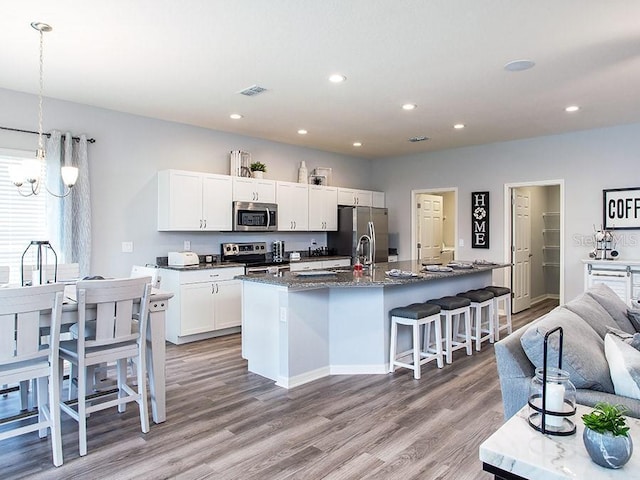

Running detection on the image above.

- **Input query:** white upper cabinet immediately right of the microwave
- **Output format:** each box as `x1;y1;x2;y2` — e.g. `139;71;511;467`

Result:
276;182;309;232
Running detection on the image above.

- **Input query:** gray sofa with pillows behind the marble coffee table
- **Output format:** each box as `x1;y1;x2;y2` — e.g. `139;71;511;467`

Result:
495;285;640;419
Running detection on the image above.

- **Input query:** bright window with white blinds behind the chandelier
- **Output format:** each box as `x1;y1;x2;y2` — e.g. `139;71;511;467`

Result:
0;149;48;284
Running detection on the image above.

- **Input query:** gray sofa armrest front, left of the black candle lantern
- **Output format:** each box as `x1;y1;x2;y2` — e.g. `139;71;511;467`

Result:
494;325;535;420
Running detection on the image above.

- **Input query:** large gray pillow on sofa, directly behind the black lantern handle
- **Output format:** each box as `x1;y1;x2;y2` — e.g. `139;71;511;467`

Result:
520;307;614;393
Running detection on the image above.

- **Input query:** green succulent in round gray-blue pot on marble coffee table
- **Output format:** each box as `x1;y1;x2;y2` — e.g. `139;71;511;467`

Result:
582;402;633;468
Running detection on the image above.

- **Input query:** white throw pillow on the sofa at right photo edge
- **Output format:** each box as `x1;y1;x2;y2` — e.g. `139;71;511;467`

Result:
604;334;640;400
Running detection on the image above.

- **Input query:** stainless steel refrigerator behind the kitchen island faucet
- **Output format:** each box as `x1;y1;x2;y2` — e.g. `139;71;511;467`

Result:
327;206;389;263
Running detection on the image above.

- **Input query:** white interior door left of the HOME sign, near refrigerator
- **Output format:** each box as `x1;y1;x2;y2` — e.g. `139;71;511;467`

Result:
417;194;443;263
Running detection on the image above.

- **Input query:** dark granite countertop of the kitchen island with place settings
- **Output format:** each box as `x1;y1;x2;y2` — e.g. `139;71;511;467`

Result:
236;261;511;290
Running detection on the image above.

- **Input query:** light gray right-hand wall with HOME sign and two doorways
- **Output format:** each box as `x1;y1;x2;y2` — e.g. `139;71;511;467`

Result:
372;124;640;300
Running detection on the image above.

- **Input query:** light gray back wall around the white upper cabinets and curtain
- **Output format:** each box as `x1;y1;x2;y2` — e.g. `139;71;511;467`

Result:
0;89;370;276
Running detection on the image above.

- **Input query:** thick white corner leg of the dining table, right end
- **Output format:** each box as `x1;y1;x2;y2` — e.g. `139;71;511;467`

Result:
147;310;167;423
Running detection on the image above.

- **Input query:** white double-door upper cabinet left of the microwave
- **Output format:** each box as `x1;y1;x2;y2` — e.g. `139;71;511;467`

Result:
158;170;233;232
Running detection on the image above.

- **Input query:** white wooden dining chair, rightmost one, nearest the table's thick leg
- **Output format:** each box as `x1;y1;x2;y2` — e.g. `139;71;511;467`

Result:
59;277;151;456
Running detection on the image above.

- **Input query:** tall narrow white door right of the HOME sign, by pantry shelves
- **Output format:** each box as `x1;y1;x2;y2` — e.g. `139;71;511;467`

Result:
511;188;532;313
